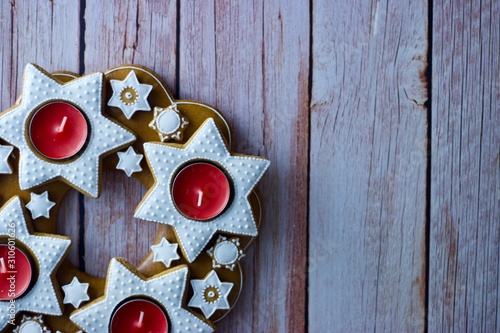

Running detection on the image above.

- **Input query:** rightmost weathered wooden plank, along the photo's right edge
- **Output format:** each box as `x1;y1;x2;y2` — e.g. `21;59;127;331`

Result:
429;0;500;332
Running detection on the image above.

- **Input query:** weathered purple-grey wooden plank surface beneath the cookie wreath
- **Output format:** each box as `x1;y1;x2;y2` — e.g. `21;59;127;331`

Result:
0;0;500;332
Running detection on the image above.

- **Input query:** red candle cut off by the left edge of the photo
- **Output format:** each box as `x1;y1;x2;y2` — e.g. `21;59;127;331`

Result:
0;244;33;301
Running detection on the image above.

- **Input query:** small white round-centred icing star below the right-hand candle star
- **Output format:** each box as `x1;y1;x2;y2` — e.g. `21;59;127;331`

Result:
207;236;245;270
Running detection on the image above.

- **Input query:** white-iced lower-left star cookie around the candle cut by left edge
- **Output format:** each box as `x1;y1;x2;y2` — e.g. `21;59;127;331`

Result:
0;197;71;331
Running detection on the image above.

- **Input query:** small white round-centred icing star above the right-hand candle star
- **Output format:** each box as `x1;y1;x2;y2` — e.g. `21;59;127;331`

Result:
149;104;189;142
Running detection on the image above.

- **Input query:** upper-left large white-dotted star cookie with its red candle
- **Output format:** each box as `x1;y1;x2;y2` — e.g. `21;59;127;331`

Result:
0;64;135;197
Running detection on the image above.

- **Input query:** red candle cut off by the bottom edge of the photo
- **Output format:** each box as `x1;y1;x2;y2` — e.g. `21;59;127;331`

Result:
111;298;168;333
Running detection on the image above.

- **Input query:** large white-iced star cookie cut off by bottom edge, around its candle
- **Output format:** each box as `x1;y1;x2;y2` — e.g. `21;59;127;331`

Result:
71;259;213;333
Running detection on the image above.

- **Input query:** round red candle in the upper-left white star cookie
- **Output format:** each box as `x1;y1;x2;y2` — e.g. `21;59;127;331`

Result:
29;102;88;160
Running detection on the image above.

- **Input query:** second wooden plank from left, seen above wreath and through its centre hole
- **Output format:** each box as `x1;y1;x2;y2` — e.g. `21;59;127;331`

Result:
81;1;177;277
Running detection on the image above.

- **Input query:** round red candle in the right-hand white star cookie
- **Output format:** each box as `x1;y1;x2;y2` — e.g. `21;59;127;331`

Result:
172;162;231;221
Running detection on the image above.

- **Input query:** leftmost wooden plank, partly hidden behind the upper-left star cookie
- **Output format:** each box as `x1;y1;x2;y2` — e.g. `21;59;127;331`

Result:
0;0;80;265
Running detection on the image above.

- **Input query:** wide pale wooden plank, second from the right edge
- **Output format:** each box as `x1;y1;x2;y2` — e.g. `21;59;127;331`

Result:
309;0;428;332
